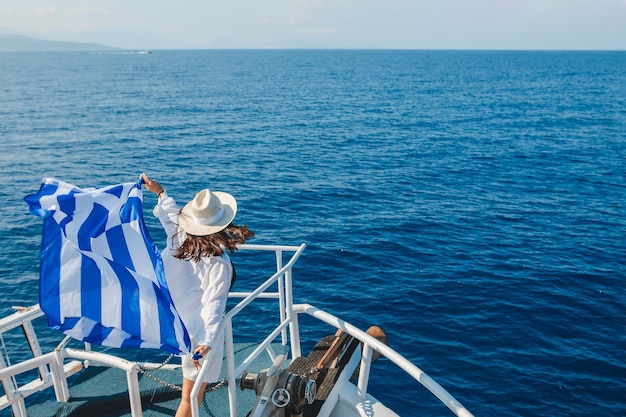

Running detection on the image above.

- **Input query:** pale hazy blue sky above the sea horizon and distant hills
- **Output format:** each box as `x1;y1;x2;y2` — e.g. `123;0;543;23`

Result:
0;0;626;50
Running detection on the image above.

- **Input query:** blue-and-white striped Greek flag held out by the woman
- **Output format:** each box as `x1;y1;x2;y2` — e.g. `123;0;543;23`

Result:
25;178;191;353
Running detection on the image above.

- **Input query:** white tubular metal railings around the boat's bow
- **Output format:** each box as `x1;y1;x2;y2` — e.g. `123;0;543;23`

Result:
0;244;472;417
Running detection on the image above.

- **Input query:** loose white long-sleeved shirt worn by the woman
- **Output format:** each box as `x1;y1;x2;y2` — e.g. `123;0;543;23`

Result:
154;192;233;349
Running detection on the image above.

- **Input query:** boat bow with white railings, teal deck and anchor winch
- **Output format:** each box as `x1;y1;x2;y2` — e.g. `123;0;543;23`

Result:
0;244;472;417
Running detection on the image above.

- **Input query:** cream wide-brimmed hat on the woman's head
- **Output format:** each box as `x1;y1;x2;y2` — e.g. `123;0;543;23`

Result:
178;188;237;236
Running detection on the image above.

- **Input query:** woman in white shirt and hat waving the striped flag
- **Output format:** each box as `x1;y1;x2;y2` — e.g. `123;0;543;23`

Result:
142;174;254;417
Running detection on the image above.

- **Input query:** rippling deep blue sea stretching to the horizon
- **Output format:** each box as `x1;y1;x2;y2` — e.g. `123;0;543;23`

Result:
0;50;626;417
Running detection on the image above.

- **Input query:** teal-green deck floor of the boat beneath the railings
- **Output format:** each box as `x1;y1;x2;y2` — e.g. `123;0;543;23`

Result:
17;343;288;417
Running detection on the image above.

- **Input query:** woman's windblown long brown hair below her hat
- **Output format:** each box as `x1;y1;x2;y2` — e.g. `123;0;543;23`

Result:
174;223;254;262
